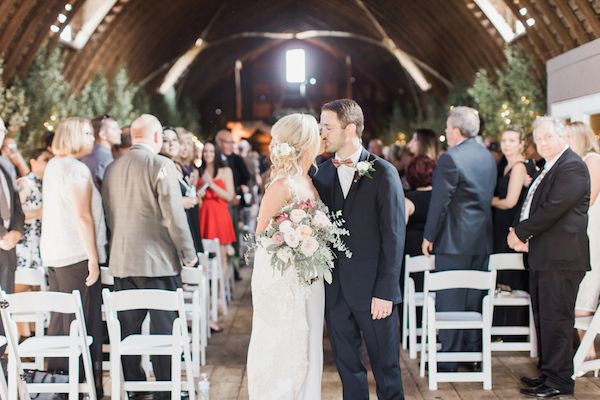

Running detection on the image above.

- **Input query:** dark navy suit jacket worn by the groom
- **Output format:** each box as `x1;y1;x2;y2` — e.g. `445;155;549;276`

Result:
313;149;406;310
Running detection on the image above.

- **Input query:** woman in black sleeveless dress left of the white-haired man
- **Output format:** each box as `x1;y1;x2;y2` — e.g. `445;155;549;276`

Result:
492;126;531;341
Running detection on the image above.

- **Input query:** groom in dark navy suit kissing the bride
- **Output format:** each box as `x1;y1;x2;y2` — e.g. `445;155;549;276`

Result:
313;99;405;400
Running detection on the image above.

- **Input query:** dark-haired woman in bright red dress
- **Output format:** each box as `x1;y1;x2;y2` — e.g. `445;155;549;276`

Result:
198;142;236;330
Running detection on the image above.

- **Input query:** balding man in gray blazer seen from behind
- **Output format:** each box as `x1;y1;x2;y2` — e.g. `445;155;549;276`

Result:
102;114;197;398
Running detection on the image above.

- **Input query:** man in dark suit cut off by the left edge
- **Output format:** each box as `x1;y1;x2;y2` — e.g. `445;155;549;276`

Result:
0;118;25;352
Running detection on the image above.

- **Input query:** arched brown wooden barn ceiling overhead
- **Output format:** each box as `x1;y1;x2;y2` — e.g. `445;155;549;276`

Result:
0;0;600;101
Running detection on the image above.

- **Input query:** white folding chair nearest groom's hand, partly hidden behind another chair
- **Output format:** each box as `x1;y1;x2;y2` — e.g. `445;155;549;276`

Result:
402;255;435;359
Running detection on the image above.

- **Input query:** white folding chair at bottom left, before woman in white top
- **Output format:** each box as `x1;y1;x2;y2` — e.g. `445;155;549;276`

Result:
3;290;96;400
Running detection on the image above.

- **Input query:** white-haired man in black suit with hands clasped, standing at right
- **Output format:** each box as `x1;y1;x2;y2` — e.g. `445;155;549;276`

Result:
507;117;590;398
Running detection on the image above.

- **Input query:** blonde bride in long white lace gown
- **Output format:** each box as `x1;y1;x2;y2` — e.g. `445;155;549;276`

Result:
248;114;325;400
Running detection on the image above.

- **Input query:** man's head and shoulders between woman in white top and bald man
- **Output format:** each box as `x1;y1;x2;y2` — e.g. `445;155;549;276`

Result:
81;114;121;190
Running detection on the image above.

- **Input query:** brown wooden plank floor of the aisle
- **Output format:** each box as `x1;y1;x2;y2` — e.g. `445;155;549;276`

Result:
108;268;600;400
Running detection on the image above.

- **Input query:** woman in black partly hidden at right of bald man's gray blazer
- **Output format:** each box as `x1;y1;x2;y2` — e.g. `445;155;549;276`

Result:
159;127;204;253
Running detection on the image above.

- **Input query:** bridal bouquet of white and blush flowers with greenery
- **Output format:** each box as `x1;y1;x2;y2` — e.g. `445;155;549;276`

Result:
257;200;352;285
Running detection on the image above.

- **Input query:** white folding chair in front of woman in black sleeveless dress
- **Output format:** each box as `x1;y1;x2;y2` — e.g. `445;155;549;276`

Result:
489;253;537;357
